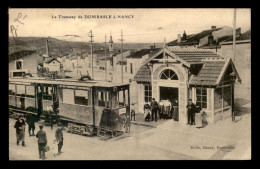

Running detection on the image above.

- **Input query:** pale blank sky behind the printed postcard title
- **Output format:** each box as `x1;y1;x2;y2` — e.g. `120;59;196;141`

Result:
8;8;251;43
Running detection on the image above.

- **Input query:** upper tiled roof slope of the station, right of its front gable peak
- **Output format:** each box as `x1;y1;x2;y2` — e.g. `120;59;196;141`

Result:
168;47;220;64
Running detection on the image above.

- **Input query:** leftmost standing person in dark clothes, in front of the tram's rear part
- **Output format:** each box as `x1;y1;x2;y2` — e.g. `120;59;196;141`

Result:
14;116;26;147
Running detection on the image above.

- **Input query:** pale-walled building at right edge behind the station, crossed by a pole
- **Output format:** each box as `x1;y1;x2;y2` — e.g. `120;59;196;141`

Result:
221;30;251;101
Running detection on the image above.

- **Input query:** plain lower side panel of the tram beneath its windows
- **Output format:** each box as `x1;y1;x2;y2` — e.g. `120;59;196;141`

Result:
59;103;93;125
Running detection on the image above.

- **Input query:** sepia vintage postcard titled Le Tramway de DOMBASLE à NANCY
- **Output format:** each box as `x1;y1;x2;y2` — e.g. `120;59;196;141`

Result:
8;8;251;160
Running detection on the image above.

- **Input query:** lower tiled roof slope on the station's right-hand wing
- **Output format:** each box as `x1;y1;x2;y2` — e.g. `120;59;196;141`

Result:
189;60;225;86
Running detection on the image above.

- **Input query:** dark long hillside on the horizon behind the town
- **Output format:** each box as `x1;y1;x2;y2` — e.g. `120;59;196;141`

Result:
9;37;163;56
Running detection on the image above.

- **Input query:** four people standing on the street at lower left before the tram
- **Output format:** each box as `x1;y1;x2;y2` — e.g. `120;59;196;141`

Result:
14;114;63;159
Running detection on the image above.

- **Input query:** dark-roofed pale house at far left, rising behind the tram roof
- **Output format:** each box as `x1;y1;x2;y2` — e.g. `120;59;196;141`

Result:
9;50;43;77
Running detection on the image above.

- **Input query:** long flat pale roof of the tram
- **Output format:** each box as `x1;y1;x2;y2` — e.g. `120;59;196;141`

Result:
9;78;129;87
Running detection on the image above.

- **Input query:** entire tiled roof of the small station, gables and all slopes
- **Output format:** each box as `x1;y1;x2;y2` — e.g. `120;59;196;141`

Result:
133;47;239;86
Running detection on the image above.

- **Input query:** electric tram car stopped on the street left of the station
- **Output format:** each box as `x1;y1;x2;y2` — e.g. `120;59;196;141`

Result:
9;78;130;136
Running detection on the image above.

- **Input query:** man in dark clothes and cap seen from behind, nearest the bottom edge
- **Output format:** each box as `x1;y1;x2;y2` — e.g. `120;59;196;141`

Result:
36;125;47;160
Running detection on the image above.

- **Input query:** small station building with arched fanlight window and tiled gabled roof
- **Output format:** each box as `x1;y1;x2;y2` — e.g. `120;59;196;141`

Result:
133;46;241;123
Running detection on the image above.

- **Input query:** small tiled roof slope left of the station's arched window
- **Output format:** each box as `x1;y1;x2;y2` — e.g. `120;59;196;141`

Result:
134;65;151;82
